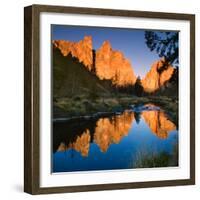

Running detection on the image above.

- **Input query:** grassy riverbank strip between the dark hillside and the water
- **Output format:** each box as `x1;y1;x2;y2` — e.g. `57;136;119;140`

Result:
53;96;178;125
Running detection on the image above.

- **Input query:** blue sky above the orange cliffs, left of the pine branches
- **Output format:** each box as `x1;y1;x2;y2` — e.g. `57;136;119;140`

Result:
52;25;173;78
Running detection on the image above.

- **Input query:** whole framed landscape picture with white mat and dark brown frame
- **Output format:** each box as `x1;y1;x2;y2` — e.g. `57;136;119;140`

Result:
24;5;195;194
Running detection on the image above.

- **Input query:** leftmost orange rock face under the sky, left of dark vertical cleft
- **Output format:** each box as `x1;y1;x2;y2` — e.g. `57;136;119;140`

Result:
53;36;93;71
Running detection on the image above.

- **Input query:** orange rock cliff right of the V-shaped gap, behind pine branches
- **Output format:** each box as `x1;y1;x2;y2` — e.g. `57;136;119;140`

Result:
142;59;174;93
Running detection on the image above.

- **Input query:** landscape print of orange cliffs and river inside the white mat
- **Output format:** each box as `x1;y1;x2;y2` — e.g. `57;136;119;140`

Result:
51;24;180;173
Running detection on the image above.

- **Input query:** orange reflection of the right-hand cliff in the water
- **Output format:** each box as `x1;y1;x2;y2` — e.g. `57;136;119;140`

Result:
142;110;176;139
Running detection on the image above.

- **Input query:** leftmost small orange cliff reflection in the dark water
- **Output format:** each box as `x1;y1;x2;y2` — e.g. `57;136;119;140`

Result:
57;129;91;157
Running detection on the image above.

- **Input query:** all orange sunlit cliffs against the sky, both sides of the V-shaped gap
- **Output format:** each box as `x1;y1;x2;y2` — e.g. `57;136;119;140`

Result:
53;36;174;93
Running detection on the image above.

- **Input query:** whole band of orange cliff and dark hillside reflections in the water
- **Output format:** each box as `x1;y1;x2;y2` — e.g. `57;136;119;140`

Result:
53;104;176;156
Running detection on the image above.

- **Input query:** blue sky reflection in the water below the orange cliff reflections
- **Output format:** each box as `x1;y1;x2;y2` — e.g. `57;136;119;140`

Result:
53;108;178;172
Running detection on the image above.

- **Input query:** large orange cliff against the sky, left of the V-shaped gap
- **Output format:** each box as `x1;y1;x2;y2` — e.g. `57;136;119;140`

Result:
53;36;136;86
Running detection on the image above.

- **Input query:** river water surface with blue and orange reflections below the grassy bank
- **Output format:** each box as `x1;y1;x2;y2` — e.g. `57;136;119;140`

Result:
52;110;178;172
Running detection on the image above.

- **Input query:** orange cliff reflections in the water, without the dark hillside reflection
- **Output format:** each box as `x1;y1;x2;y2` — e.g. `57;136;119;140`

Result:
54;106;176;156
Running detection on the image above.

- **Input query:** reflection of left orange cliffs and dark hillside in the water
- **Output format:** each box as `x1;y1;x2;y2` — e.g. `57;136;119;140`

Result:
53;112;134;156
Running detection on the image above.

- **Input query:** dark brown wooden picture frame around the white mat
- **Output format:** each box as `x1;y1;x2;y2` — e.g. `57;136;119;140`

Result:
24;5;195;194
